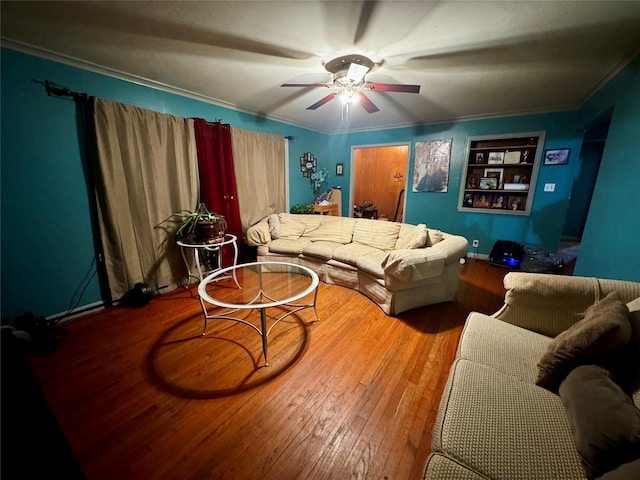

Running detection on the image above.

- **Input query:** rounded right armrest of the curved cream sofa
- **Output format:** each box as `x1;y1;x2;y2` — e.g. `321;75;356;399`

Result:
382;234;468;282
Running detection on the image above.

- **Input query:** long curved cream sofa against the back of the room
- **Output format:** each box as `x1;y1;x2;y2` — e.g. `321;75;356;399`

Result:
246;213;468;315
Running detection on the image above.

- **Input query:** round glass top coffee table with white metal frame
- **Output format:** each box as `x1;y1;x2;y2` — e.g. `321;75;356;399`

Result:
198;262;319;367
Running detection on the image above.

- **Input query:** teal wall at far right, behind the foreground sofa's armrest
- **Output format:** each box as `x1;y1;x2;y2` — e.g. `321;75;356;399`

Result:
575;57;640;281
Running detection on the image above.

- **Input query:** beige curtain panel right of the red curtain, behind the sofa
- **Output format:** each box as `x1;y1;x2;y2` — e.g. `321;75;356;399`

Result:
231;128;287;232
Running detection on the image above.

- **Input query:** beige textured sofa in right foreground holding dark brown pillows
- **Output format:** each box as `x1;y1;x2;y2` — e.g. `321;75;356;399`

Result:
424;272;640;480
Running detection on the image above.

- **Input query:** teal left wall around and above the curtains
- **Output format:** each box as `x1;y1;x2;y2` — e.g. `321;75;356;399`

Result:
0;48;326;320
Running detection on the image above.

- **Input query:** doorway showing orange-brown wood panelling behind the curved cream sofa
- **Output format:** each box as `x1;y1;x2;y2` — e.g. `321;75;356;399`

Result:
350;144;409;222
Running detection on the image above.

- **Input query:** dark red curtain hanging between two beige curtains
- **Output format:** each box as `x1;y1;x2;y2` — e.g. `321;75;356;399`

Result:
194;118;244;263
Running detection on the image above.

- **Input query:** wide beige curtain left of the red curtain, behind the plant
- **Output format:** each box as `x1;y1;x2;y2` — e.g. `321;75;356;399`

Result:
94;99;199;300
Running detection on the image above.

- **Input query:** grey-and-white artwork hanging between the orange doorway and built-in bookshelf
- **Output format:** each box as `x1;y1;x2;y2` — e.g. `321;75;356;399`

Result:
413;139;451;192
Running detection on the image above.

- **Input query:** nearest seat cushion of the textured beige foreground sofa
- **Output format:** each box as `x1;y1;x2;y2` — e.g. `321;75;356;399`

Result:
432;360;584;480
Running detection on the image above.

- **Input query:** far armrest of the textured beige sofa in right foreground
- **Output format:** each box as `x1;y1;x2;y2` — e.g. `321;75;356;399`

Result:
493;272;640;337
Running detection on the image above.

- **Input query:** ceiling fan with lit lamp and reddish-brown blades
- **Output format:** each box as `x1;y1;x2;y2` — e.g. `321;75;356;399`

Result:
281;55;420;116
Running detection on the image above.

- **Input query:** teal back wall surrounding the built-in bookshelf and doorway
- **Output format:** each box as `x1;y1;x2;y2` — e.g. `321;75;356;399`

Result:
322;112;582;254
